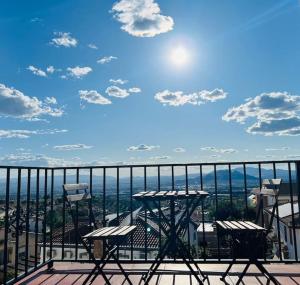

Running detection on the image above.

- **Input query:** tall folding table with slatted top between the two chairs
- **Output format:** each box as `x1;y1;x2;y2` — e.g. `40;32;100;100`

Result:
133;190;208;284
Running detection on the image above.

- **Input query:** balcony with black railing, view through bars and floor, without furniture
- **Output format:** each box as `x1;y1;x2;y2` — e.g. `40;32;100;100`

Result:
0;160;300;284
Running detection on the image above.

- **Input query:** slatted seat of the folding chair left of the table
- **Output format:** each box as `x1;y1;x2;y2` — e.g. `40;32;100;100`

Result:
83;226;136;239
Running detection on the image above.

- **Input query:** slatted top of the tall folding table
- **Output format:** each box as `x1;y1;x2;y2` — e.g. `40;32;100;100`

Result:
132;190;208;200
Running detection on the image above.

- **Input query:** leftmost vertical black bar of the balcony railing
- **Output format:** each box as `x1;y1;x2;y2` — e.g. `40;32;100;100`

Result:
3;168;10;284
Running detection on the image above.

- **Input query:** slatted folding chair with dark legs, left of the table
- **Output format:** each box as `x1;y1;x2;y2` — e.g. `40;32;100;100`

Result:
63;183;136;285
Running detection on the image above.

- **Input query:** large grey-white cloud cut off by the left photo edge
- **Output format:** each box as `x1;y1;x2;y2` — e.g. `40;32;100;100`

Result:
0;83;63;120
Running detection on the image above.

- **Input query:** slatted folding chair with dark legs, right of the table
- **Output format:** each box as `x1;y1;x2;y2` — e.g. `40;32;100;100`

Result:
216;179;282;285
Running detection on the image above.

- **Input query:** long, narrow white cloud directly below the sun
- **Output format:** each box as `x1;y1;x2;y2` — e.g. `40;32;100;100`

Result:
154;89;227;106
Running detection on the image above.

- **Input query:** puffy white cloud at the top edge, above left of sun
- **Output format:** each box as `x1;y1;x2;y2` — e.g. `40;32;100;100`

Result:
112;0;174;37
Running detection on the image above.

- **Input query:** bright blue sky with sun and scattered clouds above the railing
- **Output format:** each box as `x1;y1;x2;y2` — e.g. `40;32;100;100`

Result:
0;0;300;166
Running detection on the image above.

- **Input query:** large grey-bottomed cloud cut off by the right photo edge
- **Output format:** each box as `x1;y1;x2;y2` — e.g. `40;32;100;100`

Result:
222;92;300;136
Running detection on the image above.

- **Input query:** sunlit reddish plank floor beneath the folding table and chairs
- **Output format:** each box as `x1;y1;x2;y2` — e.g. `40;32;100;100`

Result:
17;262;300;285
